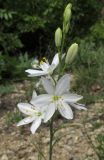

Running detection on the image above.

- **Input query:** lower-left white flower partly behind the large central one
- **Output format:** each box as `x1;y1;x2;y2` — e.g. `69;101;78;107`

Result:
17;92;50;134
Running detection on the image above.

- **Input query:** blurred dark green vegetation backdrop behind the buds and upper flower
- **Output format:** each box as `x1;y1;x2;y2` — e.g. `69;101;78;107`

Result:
0;0;104;103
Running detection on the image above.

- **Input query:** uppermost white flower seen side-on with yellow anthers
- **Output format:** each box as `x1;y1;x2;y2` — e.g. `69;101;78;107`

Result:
26;53;59;77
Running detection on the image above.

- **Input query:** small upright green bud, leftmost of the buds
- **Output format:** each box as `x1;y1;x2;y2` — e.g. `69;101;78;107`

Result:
55;28;62;47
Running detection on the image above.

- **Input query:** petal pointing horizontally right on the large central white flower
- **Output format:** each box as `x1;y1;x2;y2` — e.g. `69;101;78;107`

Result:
62;94;83;103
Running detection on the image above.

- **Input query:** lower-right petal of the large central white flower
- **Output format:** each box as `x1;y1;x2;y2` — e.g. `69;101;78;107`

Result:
58;102;73;119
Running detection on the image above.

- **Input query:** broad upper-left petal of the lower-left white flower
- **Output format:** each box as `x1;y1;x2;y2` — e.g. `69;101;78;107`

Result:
17;103;36;115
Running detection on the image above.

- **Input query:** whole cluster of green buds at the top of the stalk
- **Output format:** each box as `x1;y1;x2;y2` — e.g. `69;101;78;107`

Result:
55;3;78;65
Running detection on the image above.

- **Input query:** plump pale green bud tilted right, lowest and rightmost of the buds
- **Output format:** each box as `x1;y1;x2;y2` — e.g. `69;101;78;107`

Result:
65;43;78;64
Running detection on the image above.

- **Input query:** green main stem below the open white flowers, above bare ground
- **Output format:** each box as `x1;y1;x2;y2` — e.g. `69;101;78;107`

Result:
49;117;53;160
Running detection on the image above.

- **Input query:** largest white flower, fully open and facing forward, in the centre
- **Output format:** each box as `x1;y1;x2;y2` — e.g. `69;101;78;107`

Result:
31;74;86;122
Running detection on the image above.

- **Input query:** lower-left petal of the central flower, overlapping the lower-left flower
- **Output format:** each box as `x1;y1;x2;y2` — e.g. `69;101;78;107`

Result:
44;103;56;123
